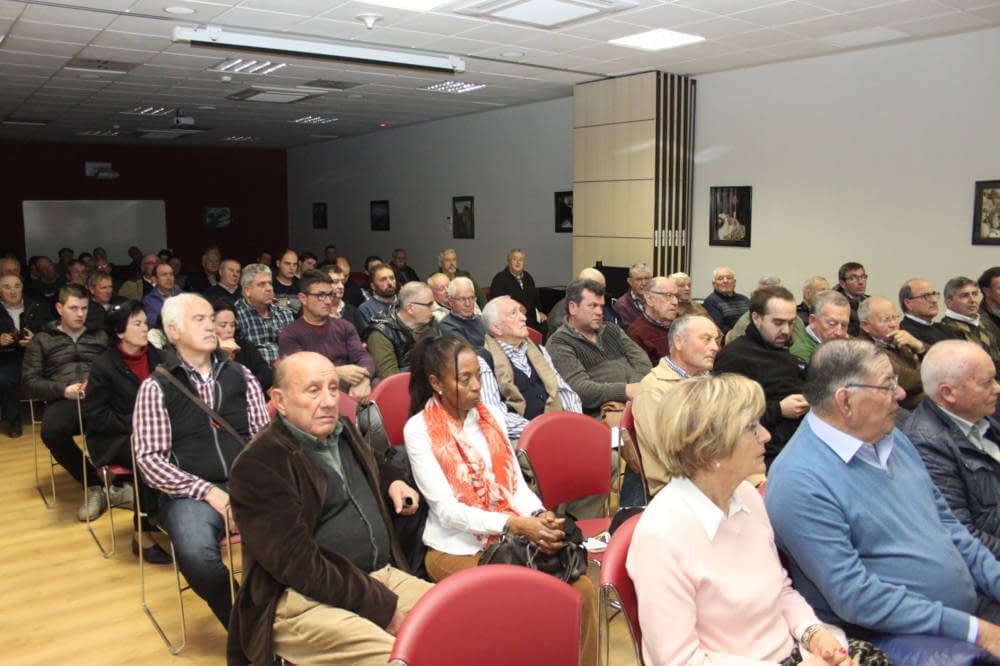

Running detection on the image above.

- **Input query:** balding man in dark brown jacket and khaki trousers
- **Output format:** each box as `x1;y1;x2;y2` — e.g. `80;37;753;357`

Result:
227;352;431;666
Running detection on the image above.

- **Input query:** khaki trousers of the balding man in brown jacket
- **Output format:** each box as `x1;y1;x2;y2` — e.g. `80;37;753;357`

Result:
272;566;433;666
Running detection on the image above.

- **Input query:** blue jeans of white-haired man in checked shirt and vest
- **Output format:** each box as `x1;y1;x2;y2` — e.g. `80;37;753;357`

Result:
157;484;232;627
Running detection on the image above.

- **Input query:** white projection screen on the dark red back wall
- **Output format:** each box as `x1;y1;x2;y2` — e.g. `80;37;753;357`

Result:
22;200;167;266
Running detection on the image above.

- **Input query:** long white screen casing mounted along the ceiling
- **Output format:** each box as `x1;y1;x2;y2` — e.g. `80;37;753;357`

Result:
174;26;465;73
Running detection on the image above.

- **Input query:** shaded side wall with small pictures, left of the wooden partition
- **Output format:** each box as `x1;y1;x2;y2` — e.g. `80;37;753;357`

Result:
288;98;573;286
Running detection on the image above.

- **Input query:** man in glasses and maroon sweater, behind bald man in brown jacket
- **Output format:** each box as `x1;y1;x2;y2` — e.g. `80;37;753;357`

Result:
278;269;375;403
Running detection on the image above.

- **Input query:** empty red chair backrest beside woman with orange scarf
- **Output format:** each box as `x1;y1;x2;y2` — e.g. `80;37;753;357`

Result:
518;412;611;509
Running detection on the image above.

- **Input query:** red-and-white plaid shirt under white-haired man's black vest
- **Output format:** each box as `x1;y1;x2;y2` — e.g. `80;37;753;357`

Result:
132;358;268;499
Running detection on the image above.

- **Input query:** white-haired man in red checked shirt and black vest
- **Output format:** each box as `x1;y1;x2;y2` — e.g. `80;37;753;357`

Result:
132;294;268;626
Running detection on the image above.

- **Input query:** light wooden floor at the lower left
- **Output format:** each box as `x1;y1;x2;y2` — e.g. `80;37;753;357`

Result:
0;427;636;666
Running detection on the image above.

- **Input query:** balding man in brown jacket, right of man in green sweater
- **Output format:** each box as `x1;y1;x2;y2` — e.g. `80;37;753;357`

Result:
858;296;928;411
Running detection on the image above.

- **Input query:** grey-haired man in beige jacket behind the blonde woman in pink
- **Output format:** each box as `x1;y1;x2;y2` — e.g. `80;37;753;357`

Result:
632;315;722;496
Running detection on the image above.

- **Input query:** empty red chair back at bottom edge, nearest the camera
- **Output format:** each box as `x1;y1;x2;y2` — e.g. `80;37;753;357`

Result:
389;564;583;666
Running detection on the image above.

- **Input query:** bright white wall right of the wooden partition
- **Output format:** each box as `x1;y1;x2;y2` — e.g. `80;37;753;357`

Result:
692;30;1000;308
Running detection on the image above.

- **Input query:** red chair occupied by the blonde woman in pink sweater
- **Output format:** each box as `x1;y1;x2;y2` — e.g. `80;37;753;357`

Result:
597;514;643;666
